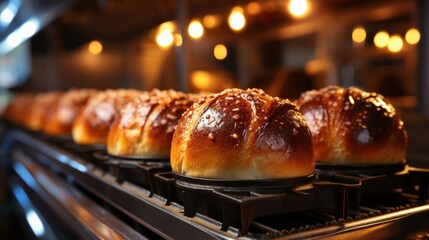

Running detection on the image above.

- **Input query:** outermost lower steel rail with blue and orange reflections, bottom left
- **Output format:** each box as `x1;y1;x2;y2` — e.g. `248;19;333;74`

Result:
12;149;145;239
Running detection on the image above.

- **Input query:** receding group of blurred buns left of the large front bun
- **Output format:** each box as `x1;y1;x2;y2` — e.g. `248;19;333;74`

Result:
5;89;200;159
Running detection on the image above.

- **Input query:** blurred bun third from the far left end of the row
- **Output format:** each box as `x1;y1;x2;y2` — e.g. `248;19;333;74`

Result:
43;89;97;136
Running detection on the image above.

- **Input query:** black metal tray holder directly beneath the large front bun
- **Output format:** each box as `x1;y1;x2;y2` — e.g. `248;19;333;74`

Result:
155;172;360;235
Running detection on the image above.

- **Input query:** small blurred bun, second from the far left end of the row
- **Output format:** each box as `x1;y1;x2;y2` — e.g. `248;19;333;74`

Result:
23;92;61;131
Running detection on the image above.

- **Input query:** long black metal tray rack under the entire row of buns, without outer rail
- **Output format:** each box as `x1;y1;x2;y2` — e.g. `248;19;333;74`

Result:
5;127;429;239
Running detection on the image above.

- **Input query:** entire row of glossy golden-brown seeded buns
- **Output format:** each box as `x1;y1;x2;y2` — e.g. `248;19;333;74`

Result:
2;86;407;179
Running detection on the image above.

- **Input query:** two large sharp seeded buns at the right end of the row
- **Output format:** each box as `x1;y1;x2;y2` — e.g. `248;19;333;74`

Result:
170;86;407;179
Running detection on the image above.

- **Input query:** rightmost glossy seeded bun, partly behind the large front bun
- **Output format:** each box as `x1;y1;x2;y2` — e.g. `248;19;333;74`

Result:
297;86;407;165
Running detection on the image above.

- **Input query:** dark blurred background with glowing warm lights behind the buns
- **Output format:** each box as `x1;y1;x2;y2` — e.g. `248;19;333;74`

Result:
0;0;429;237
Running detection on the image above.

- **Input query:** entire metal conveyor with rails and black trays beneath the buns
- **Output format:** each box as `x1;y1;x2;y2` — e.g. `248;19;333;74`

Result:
1;125;429;239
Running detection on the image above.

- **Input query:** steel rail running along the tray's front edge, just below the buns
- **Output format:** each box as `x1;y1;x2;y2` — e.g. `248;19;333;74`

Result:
8;130;238;239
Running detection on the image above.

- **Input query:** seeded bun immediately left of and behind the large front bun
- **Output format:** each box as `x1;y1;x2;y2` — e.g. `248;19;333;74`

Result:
107;89;196;158
